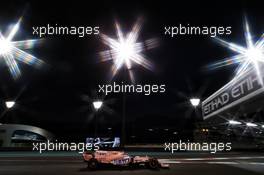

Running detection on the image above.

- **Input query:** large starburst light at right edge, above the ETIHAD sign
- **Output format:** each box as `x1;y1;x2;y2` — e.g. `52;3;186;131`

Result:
209;20;264;85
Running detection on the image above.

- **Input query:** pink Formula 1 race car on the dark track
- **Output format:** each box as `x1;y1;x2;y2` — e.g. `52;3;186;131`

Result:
83;150;169;170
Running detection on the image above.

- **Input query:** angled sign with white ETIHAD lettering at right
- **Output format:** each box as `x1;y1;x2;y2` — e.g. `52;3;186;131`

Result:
202;66;264;119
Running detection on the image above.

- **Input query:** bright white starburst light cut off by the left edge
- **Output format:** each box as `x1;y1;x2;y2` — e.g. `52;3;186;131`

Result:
0;17;44;79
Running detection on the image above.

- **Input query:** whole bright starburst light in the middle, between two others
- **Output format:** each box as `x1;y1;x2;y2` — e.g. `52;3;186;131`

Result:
100;18;157;82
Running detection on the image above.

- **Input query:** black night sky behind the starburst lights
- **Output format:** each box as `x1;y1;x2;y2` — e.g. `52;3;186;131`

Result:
0;0;264;142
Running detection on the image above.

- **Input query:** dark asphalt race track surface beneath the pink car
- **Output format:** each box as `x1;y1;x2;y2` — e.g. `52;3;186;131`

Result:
0;152;264;175
